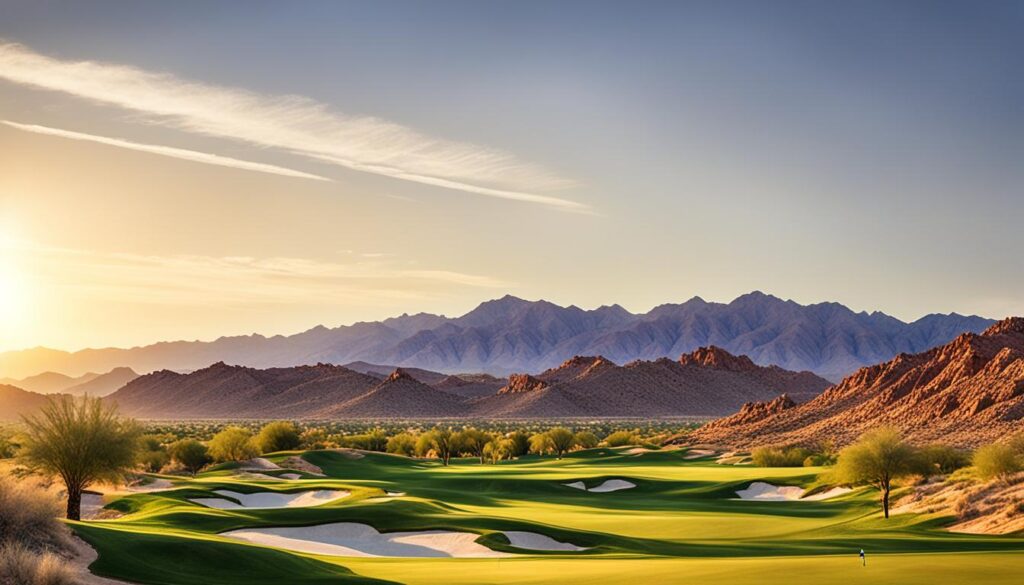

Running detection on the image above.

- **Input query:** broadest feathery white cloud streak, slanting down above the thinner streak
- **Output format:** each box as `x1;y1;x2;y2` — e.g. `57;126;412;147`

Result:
0;43;589;212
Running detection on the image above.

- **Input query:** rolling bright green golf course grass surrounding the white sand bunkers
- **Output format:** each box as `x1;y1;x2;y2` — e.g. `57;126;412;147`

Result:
74;449;1024;585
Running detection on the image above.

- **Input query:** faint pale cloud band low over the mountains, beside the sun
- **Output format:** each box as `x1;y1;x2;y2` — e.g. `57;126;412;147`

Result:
14;242;512;307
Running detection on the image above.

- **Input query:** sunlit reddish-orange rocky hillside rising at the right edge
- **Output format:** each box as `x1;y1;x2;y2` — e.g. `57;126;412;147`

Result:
687;317;1024;447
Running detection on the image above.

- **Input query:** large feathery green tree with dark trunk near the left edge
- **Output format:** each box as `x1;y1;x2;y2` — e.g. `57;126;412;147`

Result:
22;395;141;520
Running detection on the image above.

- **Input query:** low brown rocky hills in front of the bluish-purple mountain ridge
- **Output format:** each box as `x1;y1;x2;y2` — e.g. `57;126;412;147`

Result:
99;347;828;419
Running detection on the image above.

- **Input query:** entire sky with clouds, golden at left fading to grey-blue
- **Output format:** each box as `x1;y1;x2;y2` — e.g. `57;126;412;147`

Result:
0;0;1024;350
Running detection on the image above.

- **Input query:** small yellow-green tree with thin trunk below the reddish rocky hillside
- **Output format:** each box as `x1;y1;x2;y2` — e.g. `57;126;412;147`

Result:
836;427;921;518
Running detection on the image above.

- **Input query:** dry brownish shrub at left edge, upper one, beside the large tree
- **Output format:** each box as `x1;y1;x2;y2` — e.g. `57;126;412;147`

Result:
0;476;70;553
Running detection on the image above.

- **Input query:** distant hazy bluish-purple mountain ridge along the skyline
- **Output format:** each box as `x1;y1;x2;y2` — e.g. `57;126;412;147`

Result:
0;292;994;380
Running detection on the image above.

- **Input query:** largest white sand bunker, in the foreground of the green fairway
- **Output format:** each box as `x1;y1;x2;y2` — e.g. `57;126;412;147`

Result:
221;523;511;558
